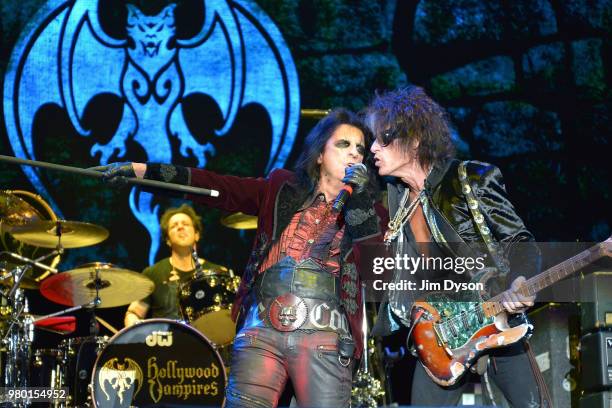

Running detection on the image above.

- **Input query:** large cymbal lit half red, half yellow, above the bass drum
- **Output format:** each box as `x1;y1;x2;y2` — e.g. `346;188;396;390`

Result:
40;262;155;308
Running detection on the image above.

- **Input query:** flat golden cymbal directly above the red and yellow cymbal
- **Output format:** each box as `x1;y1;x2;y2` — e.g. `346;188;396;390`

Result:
11;220;108;248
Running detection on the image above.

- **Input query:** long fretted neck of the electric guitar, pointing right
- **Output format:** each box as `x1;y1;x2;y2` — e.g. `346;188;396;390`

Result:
483;244;602;316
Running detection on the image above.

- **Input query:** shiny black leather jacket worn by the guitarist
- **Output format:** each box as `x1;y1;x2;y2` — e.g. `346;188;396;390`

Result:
372;160;540;335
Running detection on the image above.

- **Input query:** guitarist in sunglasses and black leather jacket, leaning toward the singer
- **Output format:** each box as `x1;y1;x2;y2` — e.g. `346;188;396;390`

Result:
366;86;546;407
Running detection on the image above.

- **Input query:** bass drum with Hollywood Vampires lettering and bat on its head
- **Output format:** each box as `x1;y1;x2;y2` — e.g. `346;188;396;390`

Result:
91;319;227;408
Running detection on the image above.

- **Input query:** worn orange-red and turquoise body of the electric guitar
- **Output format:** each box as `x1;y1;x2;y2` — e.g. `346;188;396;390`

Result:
412;293;531;386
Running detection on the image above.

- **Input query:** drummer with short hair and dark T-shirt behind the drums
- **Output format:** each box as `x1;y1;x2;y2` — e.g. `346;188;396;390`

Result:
124;204;229;327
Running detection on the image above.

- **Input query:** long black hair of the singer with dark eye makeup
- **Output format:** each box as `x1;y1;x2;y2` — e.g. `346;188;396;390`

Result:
294;108;372;191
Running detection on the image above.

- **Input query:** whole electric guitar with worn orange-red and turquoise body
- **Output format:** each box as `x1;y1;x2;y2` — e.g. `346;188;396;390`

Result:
411;237;612;386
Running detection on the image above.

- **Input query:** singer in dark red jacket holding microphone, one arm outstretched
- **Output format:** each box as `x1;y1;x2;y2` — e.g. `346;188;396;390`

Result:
100;109;385;408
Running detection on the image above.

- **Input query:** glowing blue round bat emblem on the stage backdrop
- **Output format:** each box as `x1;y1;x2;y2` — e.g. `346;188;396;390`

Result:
4;0;299;263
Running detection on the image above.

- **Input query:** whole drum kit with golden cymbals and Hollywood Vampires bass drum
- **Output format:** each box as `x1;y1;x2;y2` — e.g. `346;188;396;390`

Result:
0;191;256;408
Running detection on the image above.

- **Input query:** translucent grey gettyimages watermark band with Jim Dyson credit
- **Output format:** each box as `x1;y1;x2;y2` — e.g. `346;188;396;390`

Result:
355;241;611;302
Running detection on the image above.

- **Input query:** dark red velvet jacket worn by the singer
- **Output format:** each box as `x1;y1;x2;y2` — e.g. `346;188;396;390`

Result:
187;169;386;358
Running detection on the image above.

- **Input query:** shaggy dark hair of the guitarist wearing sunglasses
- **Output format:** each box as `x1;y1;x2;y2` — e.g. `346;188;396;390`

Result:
365;86;455;167
